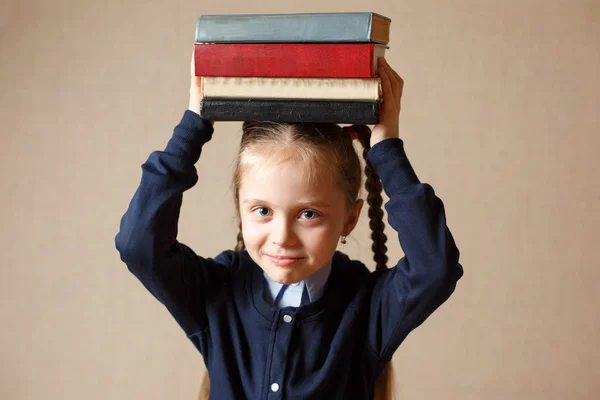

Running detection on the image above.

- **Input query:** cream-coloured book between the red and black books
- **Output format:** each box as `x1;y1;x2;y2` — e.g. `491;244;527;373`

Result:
202;76;381;102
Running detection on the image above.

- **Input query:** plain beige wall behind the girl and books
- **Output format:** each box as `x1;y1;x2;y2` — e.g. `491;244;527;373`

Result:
0;0;600;400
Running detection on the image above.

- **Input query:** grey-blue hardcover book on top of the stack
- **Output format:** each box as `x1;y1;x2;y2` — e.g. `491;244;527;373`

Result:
196;12;392;44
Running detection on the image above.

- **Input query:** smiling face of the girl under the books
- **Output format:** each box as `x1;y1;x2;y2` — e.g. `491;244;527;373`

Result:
239;156;362;283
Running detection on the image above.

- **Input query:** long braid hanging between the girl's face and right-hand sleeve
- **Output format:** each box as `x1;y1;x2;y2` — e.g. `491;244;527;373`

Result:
355;126;388;270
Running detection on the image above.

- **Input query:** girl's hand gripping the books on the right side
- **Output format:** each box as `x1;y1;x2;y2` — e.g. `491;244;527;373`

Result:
371;57;404;147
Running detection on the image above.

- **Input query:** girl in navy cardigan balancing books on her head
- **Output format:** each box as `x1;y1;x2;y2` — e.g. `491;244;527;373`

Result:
115;50;463;399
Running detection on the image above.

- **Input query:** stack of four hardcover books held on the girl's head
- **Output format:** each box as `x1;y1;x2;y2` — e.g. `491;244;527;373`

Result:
194;12;391;124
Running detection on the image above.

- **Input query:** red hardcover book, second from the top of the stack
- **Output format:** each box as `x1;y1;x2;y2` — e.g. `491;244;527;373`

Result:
194;43;387;78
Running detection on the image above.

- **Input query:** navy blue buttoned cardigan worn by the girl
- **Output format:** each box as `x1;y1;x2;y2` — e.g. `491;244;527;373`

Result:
115;110;463;400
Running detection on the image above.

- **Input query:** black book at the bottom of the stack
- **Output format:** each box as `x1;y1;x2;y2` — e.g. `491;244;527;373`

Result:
200;99;379;125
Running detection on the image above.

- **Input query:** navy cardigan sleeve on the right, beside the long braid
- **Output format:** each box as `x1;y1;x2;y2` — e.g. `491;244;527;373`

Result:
368;138;463;361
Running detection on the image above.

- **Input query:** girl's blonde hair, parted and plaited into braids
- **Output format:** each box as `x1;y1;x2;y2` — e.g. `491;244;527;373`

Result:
199;121;393;400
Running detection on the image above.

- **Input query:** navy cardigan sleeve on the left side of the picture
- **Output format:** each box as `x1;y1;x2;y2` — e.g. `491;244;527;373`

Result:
115;110;227;335
